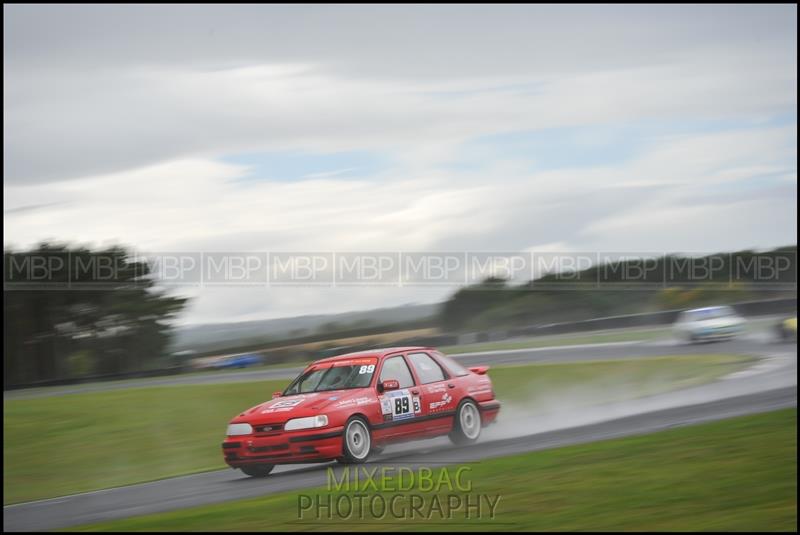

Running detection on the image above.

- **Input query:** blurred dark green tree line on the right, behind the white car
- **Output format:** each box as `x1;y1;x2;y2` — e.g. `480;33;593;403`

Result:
438;246;797;332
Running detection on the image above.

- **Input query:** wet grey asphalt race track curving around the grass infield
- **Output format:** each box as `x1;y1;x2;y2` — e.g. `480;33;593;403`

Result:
3;333;797;531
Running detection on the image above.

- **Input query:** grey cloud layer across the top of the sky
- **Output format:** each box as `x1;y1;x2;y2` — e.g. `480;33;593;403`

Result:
4;6;797;182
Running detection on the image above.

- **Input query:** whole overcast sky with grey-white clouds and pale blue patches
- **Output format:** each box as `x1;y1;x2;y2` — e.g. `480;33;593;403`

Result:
3;5;797;322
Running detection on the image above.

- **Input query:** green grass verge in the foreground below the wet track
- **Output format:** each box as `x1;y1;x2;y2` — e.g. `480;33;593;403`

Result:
67;409;797;531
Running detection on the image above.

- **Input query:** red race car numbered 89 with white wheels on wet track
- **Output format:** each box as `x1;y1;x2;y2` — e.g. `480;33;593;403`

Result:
222;347;500;477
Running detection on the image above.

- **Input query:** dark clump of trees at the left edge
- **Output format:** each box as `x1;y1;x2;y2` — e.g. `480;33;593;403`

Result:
3;243;186;387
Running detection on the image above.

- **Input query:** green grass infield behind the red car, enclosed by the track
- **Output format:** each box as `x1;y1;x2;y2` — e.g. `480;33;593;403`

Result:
3;355;748;504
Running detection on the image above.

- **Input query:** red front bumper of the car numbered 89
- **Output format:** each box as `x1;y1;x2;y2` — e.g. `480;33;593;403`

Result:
222;427;343;468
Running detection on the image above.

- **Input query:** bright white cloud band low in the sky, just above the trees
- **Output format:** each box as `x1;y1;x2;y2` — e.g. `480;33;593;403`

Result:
5;123;797;321
